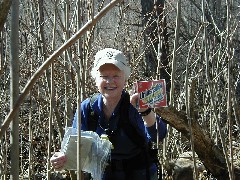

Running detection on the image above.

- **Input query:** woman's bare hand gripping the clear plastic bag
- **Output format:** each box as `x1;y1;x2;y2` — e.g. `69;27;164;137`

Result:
50;152;67;171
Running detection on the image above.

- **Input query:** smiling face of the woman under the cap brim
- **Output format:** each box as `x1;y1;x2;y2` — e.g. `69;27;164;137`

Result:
96;64;126;98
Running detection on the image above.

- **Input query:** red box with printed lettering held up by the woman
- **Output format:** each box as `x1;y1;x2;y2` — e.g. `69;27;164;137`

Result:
134;79;167;108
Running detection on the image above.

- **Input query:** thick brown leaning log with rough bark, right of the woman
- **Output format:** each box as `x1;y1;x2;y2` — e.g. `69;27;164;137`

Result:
155;107;240;180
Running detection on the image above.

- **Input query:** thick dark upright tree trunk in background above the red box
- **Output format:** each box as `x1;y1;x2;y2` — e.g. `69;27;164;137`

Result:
141;0;171;92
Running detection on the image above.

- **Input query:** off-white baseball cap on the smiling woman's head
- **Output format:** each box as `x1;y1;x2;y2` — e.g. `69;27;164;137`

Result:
92;48;131;79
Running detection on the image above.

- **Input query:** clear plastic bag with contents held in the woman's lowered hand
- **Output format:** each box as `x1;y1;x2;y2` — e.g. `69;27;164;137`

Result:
60;127;112;180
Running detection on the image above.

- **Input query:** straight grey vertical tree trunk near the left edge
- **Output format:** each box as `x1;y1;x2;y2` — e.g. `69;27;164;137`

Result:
10;0;19;180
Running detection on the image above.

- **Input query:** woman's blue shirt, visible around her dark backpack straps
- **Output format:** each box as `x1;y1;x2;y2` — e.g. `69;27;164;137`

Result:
72;91;167;175
